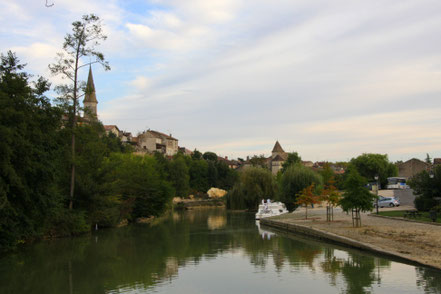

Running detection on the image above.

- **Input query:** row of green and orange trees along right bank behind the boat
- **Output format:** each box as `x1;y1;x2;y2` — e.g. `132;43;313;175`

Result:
226;152;398;225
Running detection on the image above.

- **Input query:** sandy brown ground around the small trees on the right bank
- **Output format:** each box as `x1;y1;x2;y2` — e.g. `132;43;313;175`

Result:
272;206;441;269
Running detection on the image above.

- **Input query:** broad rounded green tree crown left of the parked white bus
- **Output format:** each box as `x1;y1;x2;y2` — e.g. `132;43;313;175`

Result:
351;153;398;187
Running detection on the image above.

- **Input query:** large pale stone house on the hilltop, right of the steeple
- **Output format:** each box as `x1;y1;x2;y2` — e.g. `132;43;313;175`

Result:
138;130;178;156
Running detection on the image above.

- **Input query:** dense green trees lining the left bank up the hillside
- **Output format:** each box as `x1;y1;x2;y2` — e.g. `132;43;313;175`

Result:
0;52;237;251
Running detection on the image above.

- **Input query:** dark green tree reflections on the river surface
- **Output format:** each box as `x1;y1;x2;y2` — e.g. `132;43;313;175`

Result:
0;210;441;294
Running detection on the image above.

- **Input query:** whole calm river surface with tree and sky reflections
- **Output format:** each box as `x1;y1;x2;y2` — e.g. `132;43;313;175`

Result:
0;209;441;294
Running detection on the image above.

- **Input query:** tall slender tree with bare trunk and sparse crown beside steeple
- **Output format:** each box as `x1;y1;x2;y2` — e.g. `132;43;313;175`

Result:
49;14;110;209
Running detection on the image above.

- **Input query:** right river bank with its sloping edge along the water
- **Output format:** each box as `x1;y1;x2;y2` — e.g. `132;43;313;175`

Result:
261;207;441;269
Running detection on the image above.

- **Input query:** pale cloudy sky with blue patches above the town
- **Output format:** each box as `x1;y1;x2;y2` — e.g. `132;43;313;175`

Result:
0;0;441;161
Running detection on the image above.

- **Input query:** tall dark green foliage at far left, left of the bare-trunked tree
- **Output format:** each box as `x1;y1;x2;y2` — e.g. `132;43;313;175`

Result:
0;51;61;251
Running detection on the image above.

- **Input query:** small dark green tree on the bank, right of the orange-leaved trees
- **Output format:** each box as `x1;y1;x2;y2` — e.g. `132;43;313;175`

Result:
340;169;376;211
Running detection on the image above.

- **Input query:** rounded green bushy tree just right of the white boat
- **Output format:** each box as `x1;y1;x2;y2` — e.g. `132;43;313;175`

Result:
278;164;323;211
